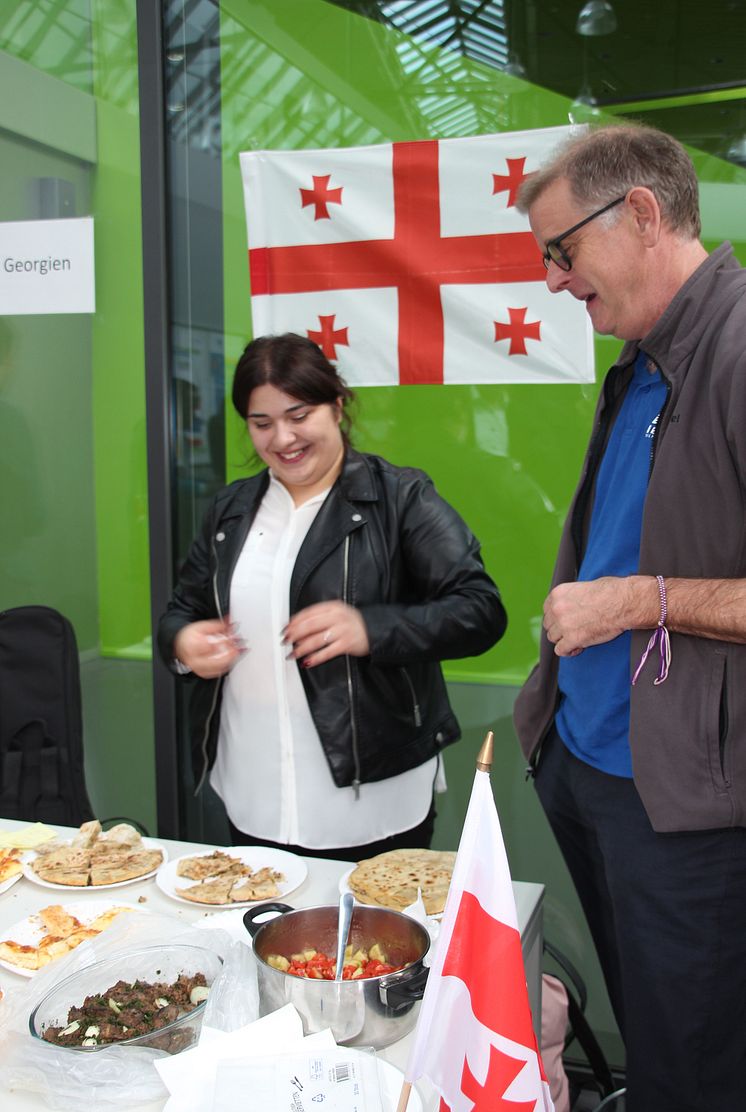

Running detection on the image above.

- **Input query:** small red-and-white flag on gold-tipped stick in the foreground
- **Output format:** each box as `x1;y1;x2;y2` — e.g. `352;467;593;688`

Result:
399;734;554;1112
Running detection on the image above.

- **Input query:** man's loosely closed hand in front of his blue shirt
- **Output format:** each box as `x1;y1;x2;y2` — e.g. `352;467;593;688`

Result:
544;575;658;656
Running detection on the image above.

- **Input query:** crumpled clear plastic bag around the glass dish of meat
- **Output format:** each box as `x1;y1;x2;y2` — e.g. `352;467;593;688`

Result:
0;913;259;1112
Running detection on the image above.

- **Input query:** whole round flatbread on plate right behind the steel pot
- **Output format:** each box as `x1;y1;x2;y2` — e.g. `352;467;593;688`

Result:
347;850;456;915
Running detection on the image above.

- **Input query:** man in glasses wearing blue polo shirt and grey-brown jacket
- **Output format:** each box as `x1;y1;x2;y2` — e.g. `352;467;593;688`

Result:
515;126;746;1112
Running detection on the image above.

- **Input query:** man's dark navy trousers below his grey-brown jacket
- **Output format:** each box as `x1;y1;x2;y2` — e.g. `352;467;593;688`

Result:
536;729;746;1112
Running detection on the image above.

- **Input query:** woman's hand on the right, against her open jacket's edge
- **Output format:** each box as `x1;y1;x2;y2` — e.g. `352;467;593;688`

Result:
282;599;370;668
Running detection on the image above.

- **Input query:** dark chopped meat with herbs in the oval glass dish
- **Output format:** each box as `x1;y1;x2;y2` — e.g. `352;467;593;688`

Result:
42;973;209;1053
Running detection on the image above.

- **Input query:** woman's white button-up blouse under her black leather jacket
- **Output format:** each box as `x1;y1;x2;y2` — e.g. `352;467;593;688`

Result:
210;473;440;850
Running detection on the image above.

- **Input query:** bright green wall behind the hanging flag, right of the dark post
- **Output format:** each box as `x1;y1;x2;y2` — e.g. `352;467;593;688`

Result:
220;0;743;684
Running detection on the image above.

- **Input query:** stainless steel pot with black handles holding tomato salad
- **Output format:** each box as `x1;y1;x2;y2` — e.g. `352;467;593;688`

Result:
243;903;430;1050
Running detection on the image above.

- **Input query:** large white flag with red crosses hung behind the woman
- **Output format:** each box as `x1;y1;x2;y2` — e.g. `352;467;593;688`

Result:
240;128;594;386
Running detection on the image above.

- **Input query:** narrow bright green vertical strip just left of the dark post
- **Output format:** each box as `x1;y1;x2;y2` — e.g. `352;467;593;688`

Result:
92;0;150;659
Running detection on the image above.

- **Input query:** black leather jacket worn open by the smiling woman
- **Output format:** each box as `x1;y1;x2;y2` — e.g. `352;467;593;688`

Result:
158;449;507;791
